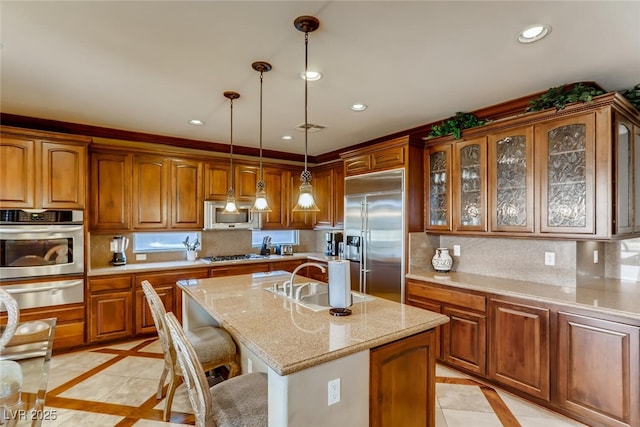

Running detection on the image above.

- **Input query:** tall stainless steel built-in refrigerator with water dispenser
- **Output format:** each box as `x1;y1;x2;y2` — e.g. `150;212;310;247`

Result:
344;169;405;302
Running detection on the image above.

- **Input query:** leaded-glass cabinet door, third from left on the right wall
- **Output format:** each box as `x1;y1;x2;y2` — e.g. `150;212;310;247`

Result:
489;126;534;233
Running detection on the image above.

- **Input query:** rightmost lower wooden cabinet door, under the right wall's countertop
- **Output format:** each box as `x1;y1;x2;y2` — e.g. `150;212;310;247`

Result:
557;312;640;426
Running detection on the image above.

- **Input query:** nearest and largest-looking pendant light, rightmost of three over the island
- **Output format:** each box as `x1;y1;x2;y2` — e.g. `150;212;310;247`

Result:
293;16;320;212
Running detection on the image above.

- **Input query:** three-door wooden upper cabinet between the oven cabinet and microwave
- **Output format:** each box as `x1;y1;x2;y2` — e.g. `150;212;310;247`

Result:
90;151;204;231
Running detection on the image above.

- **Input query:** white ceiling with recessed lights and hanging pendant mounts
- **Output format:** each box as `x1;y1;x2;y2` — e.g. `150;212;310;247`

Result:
0;0;640;155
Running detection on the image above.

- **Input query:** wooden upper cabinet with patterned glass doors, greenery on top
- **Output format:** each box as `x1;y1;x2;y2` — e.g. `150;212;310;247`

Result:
425;93;640;239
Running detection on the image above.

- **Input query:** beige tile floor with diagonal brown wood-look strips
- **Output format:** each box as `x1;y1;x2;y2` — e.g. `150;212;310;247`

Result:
43;339;583;427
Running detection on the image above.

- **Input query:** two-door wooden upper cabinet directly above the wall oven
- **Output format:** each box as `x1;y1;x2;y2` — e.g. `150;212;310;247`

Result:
0;127;91;209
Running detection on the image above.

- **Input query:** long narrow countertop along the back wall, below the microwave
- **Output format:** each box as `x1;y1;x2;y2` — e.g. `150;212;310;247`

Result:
87;252;339;277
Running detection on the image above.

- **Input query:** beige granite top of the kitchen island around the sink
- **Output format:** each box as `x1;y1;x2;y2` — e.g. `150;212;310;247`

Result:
179;272;448;375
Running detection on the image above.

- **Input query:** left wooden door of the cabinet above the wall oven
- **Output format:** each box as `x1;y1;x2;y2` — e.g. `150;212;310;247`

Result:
0;135;36;208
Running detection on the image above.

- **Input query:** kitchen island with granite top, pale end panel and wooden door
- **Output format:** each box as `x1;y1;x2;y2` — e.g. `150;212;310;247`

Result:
178;272;448;427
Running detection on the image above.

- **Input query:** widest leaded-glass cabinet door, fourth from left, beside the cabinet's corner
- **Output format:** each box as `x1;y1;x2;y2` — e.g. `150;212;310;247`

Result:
535;113;595;234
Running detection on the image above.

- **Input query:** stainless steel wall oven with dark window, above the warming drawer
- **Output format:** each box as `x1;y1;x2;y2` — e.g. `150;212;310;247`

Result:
0;209;84;279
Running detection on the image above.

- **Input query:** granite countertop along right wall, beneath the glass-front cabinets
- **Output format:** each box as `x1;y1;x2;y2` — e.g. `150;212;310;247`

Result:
406;271;640;320
